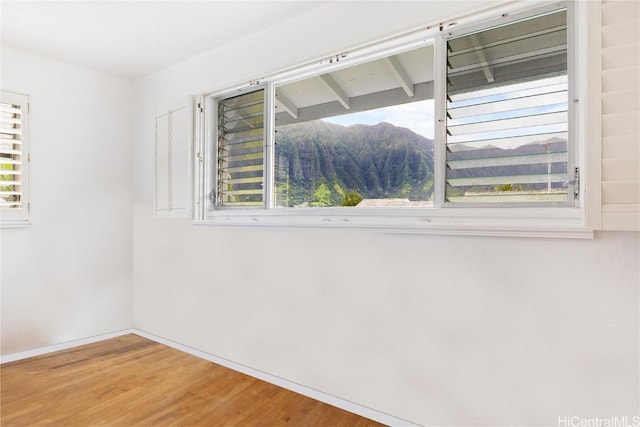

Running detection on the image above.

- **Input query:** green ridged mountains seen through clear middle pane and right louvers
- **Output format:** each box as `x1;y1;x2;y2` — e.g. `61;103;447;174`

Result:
275;120;568;206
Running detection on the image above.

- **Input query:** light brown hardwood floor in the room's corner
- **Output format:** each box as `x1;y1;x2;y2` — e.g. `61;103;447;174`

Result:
0;335;381;427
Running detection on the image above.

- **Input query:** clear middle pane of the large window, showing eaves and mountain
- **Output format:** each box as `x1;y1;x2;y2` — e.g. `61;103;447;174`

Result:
274;46;434;208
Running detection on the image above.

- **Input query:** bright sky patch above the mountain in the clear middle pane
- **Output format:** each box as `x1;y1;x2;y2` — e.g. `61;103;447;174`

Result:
322;99;434;139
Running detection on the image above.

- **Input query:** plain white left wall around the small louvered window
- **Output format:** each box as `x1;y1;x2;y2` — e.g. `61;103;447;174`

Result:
0;46;132;354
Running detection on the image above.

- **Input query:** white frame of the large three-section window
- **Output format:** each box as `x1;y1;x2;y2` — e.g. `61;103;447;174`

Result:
194;2;599;238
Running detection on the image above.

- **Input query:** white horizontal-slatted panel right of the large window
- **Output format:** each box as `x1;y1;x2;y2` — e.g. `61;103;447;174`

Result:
602;0;640;230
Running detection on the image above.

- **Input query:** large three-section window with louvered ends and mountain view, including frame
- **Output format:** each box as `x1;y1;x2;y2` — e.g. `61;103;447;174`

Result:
197;3;585;237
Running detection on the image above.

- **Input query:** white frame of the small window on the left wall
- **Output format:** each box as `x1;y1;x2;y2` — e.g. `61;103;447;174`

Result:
0;90;31;228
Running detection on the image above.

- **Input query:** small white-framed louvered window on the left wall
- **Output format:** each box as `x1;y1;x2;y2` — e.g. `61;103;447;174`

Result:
0;91;30;225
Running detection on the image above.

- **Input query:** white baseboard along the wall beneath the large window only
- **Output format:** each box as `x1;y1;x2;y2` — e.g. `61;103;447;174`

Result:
133;329;419;427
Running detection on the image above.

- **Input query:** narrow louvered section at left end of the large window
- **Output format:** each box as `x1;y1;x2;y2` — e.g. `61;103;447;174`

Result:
218;90;264;207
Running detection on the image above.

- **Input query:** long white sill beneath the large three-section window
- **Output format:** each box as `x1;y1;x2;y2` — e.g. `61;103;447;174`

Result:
195;208;593;239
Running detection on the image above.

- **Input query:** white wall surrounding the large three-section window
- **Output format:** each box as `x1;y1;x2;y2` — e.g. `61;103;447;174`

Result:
133;2;640;425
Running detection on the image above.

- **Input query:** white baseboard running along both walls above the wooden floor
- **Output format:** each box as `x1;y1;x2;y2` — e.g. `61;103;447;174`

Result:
0;329;420;427
